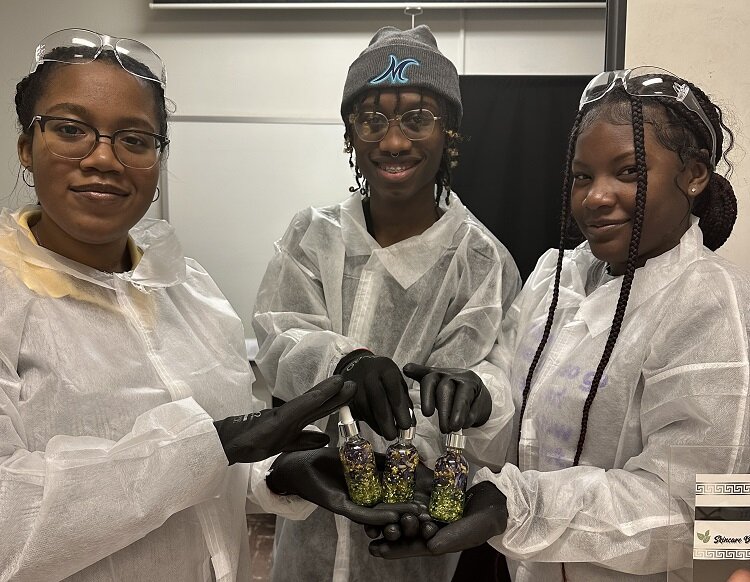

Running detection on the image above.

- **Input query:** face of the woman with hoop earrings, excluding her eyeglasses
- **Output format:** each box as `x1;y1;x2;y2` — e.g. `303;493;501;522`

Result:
18;61;159;260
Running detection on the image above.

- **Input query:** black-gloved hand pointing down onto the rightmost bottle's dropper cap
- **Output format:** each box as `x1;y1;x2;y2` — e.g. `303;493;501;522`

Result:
404;364;492;433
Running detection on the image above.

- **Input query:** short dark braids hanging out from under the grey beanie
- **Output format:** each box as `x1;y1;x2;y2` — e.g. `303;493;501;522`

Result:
344;89;463;204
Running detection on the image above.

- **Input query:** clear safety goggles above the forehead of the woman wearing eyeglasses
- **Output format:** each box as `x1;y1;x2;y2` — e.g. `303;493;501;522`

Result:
31;28;167;88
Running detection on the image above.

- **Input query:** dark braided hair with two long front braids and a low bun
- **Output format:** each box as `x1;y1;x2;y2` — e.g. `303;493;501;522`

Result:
518;78;737;466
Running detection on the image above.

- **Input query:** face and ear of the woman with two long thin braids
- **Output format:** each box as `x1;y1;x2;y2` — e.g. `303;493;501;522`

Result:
571;120;706;275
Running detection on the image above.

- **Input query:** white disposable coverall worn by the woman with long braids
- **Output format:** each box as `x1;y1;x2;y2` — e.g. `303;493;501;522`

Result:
474;217;750;582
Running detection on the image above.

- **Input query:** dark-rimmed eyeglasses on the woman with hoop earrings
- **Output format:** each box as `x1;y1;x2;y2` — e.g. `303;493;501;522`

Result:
29;115;169;170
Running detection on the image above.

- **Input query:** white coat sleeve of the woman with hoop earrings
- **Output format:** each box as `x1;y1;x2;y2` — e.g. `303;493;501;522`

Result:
0;392;227;582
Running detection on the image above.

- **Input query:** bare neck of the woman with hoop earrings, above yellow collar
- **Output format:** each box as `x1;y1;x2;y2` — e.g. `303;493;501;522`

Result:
30;216;132;273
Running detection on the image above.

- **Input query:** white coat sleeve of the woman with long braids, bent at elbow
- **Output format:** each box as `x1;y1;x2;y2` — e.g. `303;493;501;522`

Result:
475;271;749;575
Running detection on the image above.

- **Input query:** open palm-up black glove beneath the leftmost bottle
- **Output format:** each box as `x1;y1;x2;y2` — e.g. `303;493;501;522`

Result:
266;447;418;526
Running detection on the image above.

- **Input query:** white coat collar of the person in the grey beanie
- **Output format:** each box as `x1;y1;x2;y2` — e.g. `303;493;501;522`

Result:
341;193;467;289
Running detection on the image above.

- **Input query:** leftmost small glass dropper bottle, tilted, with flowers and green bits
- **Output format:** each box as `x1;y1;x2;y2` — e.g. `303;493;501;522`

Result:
339;406;382;507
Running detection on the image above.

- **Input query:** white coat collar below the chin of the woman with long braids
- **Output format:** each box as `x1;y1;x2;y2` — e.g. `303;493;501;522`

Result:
558;216;704;337
